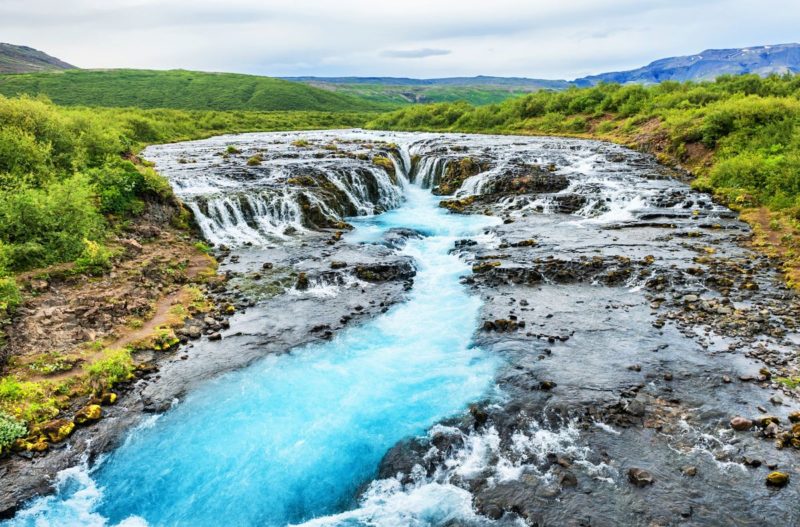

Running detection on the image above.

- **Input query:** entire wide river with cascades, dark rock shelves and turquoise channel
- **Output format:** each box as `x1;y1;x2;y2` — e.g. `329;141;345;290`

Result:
3;130;800;527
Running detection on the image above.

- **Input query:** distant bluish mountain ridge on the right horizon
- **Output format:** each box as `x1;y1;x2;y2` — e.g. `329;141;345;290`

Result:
573;44;800;86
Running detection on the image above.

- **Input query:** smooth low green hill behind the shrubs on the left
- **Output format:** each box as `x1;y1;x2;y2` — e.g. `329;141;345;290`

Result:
0;70;386;112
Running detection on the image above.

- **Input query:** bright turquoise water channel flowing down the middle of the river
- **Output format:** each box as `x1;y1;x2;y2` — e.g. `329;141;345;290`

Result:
10;186;496;526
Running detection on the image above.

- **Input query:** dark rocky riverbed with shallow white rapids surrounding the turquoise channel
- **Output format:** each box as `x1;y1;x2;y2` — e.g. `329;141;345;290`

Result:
0;131;800;525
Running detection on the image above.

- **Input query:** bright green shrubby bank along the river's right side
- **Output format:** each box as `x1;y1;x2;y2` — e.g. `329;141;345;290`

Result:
368;75;800;286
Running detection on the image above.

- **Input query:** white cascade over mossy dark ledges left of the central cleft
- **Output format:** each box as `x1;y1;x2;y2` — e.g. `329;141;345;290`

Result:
147;133;411;246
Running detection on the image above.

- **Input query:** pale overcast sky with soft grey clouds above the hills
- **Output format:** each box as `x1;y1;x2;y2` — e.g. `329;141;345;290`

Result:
0;0;800;79
